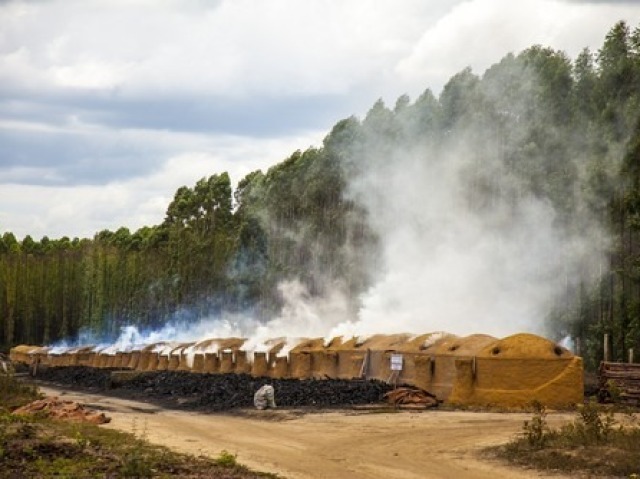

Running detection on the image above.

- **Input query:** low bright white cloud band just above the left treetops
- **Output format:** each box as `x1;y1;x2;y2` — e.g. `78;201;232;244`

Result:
0;131;322;239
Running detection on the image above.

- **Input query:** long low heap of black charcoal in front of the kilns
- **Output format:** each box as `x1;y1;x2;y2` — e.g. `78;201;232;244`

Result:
37;366;400;411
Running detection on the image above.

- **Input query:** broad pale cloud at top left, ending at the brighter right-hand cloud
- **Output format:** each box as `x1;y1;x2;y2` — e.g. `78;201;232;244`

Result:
0;0;440;95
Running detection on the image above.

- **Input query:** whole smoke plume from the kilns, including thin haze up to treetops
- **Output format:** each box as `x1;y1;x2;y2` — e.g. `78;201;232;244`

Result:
51;48;624;351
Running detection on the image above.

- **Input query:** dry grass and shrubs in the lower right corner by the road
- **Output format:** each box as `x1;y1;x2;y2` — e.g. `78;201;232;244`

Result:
490;402;640;477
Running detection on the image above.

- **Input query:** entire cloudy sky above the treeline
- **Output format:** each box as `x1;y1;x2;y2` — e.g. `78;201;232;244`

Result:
0;0;640;240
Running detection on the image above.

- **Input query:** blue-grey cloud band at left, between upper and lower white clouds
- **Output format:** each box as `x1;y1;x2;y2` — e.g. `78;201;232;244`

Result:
0;96;334;185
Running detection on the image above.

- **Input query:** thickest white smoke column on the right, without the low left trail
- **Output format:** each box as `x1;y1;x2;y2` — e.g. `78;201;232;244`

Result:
334;142;576;336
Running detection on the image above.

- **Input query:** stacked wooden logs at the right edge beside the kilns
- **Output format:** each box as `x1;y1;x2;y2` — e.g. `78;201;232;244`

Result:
598;361;640;406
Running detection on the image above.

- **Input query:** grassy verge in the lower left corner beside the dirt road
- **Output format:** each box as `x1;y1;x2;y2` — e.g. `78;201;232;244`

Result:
0;376;279;479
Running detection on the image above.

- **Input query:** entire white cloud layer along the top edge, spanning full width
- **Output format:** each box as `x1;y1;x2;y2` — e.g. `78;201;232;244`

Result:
0;0;640;102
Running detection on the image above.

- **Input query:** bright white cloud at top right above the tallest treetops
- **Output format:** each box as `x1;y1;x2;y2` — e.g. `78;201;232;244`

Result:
396;0;640;96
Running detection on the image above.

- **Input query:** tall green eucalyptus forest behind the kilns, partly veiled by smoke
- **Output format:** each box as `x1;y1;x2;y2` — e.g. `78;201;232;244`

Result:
0;22;640;367
